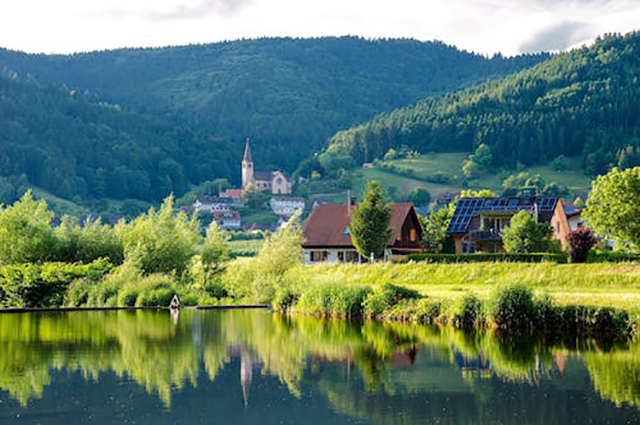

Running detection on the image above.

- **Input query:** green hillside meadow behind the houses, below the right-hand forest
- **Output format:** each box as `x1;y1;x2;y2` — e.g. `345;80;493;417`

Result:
351;152;590;199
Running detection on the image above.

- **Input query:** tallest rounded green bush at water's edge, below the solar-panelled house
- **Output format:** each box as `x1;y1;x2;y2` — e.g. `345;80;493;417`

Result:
491;284;537;330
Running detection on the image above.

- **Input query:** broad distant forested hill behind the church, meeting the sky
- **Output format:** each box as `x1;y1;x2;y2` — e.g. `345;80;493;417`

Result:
0;37;548;171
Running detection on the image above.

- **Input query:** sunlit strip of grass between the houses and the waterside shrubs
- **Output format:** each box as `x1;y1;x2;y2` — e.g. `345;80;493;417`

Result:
296;263;640;314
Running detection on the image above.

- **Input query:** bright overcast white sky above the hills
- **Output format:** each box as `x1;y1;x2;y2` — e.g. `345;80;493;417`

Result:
0;0;640;55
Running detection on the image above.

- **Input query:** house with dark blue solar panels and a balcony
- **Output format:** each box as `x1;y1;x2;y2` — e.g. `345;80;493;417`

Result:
447;196;571;254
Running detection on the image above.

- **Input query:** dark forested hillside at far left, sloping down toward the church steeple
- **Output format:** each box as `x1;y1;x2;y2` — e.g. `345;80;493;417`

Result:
0;71;237;203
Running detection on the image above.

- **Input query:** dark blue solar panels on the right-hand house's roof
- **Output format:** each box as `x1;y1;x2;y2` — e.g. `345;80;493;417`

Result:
447;196;558;233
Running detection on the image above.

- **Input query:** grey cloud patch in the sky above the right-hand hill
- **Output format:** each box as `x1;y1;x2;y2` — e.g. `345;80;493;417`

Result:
519;21;593;53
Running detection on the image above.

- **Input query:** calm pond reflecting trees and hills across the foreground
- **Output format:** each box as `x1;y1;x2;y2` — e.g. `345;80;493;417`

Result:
0;310;640;425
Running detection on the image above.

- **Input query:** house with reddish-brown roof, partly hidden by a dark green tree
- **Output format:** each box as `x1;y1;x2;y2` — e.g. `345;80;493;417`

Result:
302;204;422;264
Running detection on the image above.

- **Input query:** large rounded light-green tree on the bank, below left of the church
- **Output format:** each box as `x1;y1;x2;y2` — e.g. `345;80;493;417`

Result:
115;196;202;274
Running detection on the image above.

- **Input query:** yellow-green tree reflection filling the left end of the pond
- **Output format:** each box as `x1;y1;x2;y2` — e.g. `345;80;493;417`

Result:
0;311;198;405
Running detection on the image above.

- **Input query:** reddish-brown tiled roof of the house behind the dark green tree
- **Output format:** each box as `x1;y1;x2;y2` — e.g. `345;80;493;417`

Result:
302;204;413;247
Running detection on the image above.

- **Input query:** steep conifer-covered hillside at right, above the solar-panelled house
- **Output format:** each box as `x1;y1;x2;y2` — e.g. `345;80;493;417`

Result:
329;32;640;175
